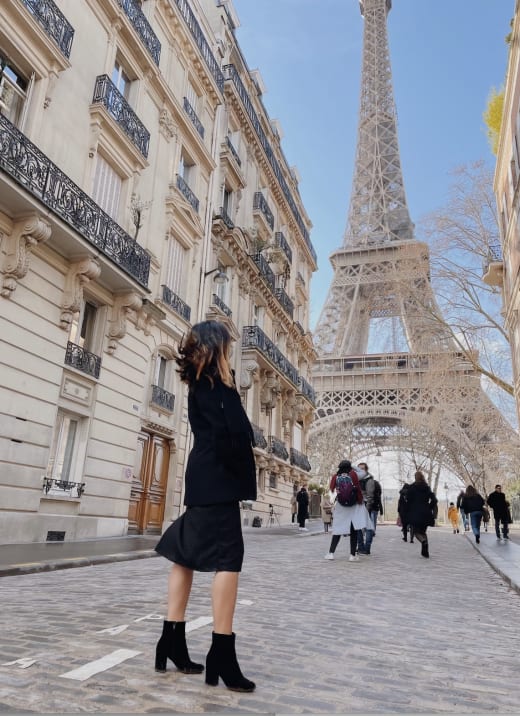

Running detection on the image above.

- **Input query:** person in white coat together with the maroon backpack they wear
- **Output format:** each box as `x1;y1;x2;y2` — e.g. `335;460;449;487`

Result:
325;460;371;562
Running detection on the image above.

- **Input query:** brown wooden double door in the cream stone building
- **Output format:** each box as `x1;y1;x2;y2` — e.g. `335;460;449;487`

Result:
128;431;170;534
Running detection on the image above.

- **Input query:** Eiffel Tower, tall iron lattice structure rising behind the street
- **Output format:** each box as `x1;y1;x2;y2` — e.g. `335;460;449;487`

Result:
309;0;517;491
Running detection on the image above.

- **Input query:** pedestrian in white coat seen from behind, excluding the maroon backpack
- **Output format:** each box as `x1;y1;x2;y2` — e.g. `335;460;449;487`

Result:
325;460;370;562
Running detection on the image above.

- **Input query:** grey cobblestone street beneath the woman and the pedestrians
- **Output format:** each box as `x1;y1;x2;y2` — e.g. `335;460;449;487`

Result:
0;526;520;714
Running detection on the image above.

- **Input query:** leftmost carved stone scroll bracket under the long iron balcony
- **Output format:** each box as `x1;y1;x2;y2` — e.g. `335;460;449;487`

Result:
0;214;51;298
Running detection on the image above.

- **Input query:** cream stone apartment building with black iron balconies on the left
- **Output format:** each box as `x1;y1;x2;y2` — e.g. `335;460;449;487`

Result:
0;0;317;543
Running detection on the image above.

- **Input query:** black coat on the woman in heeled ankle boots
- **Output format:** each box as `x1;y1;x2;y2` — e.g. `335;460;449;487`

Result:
184;376;256;506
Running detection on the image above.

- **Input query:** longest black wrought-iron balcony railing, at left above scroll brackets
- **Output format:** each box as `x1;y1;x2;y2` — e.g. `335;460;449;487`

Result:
0;115;150;286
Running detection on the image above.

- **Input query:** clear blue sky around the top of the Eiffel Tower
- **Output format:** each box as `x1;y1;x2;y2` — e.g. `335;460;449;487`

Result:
233;0;515;329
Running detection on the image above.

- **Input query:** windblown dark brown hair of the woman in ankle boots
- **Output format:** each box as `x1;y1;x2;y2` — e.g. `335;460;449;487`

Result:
175;321;234;388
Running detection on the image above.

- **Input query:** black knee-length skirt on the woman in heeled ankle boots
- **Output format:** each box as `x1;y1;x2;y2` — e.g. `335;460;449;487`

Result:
155;502;244;572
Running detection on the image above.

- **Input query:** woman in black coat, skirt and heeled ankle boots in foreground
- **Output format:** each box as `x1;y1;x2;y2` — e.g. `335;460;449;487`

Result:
155;321;256;691
